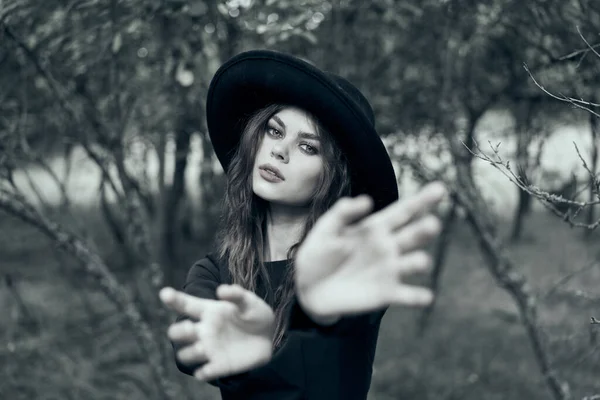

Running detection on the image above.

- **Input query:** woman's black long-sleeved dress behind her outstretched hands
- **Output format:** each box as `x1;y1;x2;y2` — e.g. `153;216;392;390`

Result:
175;257;385;400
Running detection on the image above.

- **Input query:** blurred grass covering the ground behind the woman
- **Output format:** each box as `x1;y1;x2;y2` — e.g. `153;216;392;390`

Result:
0;206;600;400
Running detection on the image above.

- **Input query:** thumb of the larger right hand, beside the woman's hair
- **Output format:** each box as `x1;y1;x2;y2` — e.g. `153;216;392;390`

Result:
318;194;373;233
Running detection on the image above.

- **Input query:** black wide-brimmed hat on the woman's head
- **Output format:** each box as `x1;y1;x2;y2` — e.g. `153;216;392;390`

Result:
206;50;398;210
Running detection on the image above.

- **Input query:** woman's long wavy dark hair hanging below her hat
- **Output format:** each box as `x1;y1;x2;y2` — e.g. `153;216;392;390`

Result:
216;104;351;349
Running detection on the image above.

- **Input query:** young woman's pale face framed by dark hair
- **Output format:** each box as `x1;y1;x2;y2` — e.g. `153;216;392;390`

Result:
252;107;324;207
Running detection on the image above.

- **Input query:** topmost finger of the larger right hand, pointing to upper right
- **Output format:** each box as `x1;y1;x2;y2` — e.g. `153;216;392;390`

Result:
372;182;446;230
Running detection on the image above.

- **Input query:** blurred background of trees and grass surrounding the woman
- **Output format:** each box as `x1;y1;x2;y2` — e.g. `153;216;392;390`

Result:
0;0;600;400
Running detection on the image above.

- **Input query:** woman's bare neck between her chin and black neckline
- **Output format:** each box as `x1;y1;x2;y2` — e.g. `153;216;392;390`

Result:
265;203;308;261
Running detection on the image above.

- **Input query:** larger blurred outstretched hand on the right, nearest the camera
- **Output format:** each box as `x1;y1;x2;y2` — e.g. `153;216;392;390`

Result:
295;183;445;321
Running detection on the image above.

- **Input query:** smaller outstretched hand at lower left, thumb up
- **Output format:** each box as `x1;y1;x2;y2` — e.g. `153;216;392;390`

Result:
159;285;275;381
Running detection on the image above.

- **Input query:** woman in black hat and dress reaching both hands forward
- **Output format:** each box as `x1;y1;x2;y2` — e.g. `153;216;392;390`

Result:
160;50;444;400
